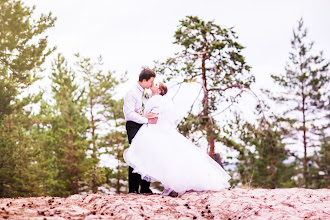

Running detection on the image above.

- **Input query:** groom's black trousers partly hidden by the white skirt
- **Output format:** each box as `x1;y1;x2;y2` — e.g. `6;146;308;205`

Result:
126;121;151;193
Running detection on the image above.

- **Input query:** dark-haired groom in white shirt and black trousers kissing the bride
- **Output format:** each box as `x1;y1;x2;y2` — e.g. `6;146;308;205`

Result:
123;68;158;193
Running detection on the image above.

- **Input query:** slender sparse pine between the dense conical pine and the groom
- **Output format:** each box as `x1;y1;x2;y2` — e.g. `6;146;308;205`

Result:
76;54;119;192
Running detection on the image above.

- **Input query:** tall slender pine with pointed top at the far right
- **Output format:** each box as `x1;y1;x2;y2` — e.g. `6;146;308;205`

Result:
272;19;330;187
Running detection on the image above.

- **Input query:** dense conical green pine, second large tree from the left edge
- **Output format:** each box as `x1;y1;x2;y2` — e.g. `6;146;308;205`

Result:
46;54;90;196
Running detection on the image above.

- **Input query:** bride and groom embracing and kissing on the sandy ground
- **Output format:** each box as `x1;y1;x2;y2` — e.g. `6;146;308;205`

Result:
123;68;230;196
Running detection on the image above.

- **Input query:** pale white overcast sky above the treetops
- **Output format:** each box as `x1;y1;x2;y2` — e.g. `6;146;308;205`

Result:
24;0;330;165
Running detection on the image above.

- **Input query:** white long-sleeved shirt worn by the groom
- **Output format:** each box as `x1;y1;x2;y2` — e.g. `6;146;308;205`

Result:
123;83;150;124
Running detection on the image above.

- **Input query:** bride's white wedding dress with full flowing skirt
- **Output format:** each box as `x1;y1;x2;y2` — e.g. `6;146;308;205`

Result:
124;95;230;195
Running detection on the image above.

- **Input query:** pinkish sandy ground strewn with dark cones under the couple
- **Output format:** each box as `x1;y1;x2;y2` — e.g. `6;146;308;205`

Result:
0;188;330;220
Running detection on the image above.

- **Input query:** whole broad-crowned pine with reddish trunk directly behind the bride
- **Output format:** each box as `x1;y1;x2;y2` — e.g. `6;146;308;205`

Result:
155;16;254;163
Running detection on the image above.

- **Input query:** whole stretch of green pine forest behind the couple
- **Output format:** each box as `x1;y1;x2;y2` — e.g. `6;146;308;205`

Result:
0;0;330;197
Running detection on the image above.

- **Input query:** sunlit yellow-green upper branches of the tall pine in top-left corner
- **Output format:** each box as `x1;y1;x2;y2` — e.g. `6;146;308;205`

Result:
0;0;55;119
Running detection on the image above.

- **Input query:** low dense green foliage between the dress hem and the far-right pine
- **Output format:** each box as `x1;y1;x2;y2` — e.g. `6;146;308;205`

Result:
223;113;295;188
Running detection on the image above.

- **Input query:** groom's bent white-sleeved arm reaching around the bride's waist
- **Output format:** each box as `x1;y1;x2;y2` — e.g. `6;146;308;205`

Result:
123;92;148;124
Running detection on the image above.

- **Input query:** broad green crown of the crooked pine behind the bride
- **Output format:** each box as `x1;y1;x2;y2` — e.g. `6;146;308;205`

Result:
155;16;254;102
